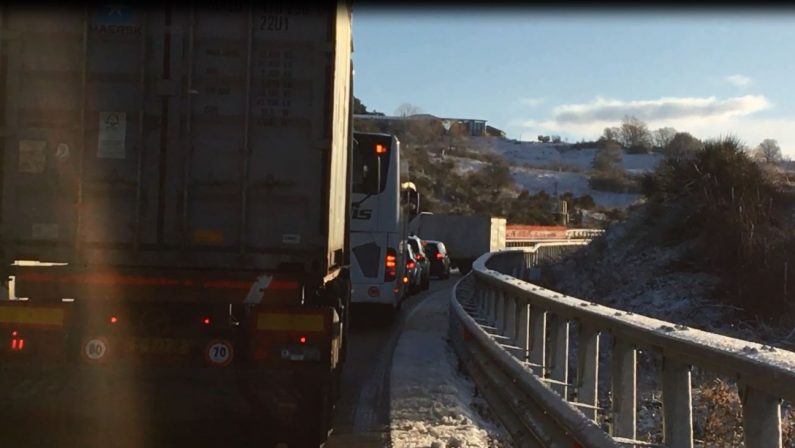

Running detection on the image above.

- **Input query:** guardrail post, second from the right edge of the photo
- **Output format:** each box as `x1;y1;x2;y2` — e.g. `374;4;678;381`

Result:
662;357;693;448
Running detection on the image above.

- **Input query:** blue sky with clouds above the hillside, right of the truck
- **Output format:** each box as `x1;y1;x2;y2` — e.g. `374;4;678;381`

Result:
353;4;795;158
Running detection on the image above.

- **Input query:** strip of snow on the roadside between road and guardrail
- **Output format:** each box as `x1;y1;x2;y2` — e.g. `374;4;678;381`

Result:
390;289;508;448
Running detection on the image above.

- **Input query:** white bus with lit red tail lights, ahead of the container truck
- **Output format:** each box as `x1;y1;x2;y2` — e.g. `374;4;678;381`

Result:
350;132;419;317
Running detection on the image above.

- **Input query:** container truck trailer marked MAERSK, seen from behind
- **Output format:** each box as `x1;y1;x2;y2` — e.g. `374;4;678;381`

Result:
0;2;352;446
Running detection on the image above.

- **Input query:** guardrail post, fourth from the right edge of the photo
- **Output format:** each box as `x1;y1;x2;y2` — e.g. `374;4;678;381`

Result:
577;323;599;421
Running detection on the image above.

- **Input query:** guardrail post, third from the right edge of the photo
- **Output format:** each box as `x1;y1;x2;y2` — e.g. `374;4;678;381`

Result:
611;337;637;440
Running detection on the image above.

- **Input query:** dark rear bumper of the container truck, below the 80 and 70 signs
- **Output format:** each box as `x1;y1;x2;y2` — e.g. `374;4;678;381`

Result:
0;363;332;424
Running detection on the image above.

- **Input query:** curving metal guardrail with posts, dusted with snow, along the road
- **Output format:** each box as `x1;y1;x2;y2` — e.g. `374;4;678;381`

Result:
450;242;795;448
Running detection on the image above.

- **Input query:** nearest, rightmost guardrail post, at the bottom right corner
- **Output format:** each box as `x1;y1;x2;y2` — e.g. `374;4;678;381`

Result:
738;384;782;448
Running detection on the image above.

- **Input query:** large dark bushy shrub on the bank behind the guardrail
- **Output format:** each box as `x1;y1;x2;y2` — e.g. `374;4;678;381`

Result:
641;137;795;316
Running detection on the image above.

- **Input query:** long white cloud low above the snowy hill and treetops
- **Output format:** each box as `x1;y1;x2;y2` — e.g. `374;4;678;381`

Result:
509;95;795;159
